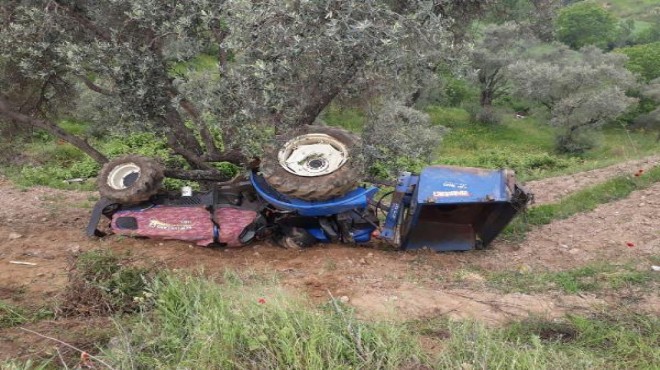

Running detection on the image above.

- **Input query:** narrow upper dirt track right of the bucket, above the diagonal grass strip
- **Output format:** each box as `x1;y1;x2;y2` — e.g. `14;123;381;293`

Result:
525;155;660;204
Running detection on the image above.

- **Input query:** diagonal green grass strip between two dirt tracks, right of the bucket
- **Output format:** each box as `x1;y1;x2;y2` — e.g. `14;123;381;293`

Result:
504;166;660;237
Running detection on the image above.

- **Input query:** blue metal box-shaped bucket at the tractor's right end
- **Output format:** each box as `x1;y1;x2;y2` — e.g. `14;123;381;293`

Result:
400;166;530;251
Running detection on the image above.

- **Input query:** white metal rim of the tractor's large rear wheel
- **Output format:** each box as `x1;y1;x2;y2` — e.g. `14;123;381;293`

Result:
277;134;348;177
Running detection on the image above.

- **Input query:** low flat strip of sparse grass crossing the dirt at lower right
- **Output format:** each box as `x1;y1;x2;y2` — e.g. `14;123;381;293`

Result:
488;262;660;294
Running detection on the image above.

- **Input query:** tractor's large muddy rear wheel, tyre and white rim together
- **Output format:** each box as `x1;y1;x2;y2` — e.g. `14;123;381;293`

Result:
260;126;362;201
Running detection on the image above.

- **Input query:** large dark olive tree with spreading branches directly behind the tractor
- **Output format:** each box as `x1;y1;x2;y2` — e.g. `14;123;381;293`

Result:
0;0;488;180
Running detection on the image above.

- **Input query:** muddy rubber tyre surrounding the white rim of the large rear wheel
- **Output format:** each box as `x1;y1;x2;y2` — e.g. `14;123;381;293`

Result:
260;126;362;201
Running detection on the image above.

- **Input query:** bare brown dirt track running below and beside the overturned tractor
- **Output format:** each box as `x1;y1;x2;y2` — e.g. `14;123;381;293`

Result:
0;156;660;360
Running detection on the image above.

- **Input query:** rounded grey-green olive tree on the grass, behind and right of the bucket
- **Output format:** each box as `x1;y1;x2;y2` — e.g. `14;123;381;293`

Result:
509;46;637;153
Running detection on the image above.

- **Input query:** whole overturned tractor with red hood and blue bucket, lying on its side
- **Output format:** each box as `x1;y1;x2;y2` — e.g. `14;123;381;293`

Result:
87;126;530;251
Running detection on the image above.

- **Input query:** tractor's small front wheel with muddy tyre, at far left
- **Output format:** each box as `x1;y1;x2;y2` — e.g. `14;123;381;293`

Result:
96;155;164;204
